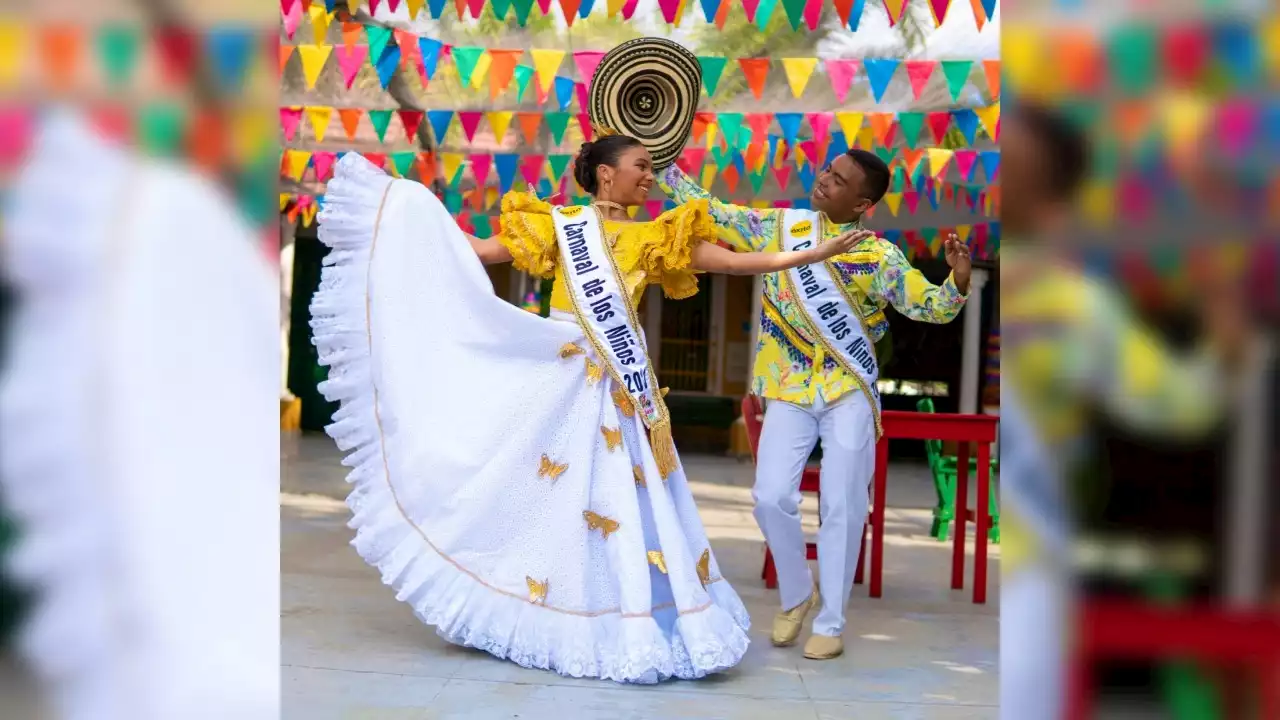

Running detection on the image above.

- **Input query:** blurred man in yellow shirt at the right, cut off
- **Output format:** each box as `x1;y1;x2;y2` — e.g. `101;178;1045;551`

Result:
1000;104;1247;720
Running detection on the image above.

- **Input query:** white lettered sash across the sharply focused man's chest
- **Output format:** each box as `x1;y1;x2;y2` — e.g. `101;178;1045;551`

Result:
778;209;881;438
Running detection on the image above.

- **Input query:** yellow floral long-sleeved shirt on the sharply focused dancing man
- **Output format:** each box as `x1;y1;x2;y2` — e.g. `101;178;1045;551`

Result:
658;165;965;405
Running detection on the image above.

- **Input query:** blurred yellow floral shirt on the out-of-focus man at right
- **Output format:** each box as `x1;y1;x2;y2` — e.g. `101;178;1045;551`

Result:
1000;252;1222;573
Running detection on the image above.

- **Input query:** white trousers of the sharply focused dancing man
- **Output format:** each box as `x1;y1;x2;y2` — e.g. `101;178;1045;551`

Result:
751;391;876;635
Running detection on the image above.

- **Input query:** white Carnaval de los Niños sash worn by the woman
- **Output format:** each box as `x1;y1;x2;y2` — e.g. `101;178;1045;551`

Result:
552;206;675;477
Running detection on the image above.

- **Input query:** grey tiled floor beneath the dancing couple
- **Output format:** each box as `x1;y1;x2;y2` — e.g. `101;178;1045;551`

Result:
280;427;1000;720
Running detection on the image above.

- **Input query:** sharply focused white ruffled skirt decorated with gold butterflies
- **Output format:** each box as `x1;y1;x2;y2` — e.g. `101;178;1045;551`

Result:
311;154;749;683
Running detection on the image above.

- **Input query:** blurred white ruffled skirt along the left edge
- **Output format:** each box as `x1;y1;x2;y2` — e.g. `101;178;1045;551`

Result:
0;113;279;720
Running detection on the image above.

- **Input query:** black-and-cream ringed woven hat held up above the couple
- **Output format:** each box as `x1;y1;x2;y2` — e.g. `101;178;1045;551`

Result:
588;37;703;169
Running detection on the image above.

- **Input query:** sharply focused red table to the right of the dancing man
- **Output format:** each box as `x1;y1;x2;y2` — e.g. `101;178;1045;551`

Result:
870;410;1000;603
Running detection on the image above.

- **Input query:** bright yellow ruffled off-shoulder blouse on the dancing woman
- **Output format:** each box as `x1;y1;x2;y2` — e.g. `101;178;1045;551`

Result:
498;192;716;313
